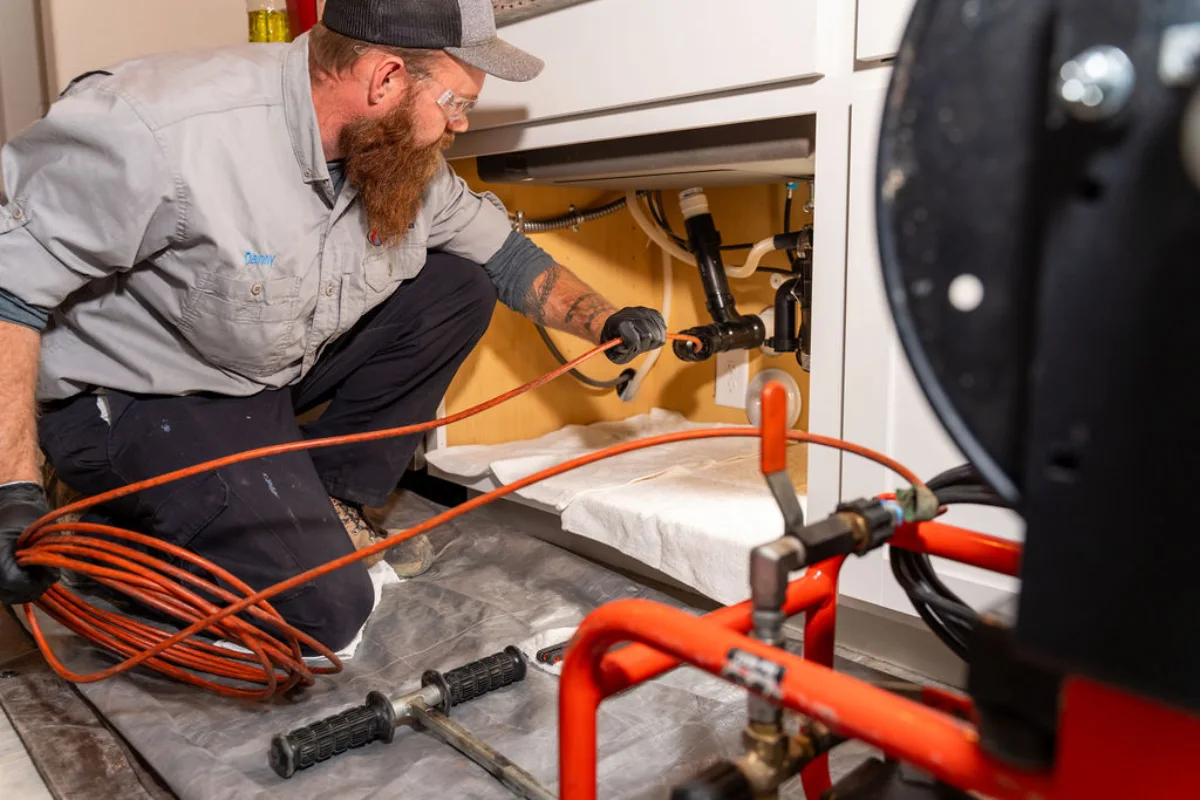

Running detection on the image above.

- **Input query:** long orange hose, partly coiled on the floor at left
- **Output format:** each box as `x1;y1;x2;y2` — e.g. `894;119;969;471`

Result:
9;333;920;700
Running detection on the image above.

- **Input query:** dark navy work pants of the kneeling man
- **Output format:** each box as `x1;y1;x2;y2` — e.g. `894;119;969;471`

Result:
38;253;496;650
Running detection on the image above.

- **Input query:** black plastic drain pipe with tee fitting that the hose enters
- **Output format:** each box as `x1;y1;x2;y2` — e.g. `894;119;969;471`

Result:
673;188;767;361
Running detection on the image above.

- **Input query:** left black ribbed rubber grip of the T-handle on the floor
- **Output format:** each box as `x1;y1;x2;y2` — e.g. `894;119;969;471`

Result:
270;692;396;777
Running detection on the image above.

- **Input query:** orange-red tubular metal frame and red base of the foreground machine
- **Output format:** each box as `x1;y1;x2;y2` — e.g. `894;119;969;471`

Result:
559;522;1200;800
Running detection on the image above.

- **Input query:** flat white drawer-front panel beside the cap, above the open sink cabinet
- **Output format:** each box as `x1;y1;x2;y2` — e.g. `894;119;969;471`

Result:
470;0;818;130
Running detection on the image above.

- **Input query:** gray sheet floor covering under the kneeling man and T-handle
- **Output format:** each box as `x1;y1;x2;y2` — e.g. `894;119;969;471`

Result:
4;498;880;800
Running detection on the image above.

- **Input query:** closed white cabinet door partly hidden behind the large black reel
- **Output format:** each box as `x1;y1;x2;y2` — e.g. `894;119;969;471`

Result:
842;88;1024;613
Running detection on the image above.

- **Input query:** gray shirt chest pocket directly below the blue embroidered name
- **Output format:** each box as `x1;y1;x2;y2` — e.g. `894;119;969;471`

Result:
180;272;300;378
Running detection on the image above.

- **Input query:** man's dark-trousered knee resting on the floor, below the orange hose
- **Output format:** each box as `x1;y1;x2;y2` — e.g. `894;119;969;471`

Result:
278;564;374;652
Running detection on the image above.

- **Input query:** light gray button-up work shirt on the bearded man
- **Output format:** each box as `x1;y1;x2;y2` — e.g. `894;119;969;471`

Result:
0;36;548;401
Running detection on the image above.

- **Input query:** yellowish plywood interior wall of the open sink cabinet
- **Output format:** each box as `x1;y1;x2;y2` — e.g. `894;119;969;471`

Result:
446;161;811;445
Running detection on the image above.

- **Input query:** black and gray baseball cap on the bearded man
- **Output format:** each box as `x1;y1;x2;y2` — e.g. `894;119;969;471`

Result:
322;0;545;80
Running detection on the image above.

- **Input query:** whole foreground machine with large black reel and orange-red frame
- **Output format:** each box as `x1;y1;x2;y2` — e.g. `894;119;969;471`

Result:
559;0;1200;800
